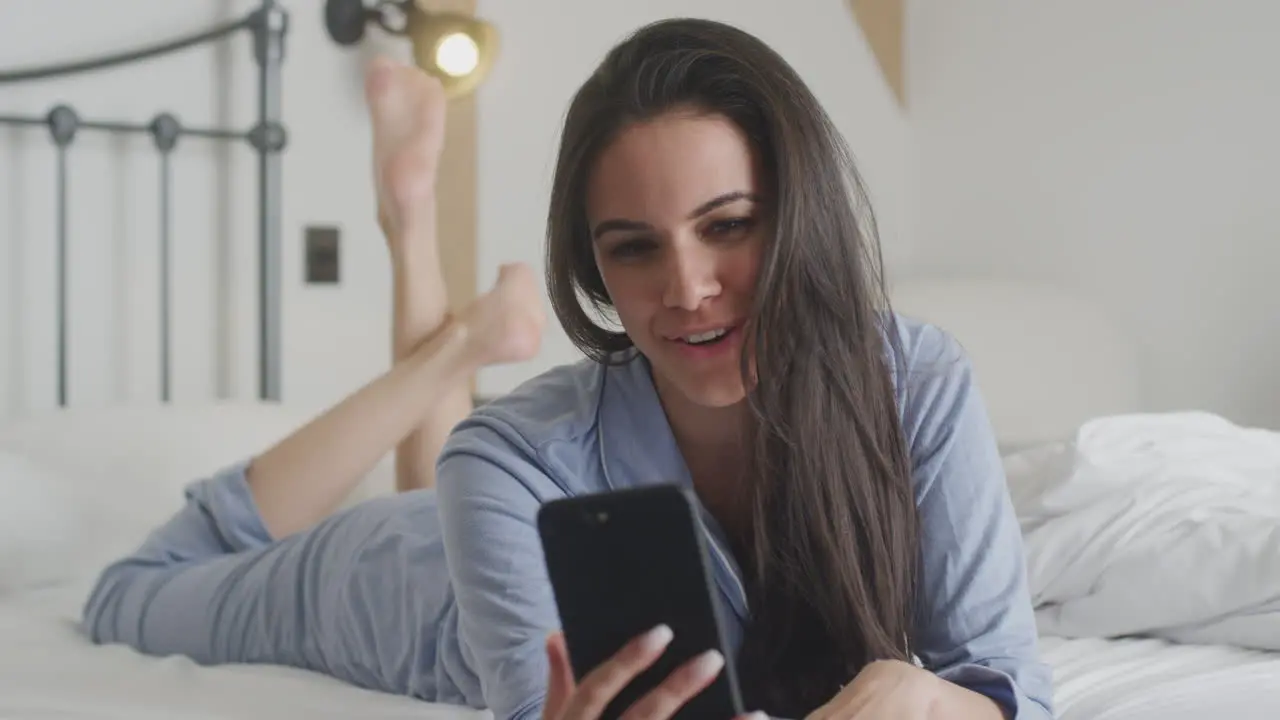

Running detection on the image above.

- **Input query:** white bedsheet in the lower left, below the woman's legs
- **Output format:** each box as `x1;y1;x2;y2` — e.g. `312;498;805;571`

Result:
0;583;492;720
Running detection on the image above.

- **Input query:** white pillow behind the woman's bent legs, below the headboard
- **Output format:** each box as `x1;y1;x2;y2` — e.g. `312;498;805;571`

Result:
0;402;394;591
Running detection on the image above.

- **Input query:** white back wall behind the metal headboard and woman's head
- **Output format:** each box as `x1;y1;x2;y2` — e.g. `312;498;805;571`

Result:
0;0;909;419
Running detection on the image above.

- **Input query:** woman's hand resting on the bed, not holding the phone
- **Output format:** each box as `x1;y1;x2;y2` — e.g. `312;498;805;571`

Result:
805;660;943;720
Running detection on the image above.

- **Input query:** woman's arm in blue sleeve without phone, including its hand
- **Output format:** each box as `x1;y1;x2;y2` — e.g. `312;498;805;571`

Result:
805;327;1052;720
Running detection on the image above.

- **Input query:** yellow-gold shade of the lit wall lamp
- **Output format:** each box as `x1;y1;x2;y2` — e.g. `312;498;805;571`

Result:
404;3;498;97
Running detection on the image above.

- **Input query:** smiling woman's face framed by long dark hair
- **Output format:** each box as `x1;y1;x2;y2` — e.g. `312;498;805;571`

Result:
586;113;767;407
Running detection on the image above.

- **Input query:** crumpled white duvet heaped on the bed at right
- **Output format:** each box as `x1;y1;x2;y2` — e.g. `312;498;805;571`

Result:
1007;413;1280;651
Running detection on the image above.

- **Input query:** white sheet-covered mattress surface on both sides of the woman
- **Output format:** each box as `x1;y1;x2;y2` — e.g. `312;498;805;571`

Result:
0;573;1280;720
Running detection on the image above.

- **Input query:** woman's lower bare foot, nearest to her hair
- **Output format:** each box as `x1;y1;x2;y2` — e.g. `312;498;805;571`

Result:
458;264;547;366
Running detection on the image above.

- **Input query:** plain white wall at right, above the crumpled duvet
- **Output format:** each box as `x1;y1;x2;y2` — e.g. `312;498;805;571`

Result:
908;0;1280;427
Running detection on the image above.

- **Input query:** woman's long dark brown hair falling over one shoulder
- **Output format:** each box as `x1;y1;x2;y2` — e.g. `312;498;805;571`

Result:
547;19;919;717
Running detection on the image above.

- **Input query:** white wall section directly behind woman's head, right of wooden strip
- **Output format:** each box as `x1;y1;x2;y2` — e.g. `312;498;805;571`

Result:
479;0;910;392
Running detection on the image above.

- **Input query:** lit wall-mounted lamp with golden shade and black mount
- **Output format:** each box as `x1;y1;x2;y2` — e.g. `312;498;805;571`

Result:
325;0;498;97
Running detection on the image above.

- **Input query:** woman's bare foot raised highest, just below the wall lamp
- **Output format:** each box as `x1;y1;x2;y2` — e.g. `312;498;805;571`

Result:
365;56;447;256
